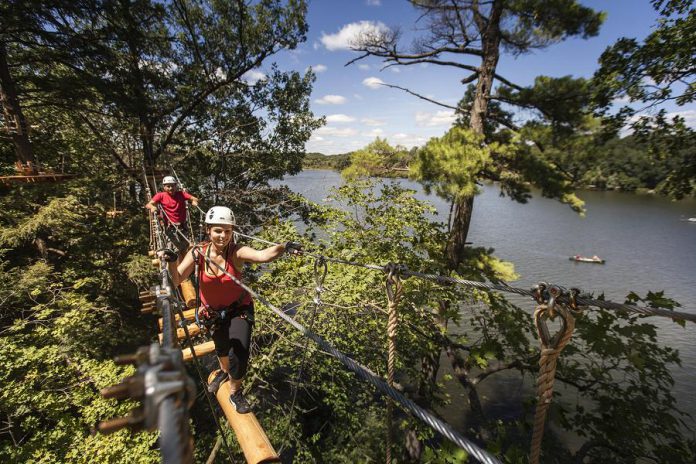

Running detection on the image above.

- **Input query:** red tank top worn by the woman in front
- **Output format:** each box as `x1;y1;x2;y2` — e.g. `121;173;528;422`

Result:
198;244;251;309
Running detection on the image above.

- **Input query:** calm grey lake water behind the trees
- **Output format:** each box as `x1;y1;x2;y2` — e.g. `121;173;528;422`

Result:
272;171;696;425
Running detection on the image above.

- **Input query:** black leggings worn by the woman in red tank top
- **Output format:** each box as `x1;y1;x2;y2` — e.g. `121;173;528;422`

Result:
213;305;254;380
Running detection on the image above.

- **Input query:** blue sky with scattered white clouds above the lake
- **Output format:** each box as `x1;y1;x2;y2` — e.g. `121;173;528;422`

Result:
260;0;696;154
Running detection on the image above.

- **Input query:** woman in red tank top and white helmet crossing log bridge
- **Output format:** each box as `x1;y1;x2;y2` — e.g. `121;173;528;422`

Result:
169;206;300;414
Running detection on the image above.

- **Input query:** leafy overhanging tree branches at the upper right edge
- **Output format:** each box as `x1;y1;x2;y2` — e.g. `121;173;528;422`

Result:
593;0;696;199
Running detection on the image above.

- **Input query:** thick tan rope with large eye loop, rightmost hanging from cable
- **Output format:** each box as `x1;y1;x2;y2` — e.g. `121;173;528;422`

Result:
529;286;575;464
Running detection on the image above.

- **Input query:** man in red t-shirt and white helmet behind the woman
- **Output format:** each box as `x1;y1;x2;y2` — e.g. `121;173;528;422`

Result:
145;176;198;253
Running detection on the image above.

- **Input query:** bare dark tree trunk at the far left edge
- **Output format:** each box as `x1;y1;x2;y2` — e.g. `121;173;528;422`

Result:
0;42;37;174
